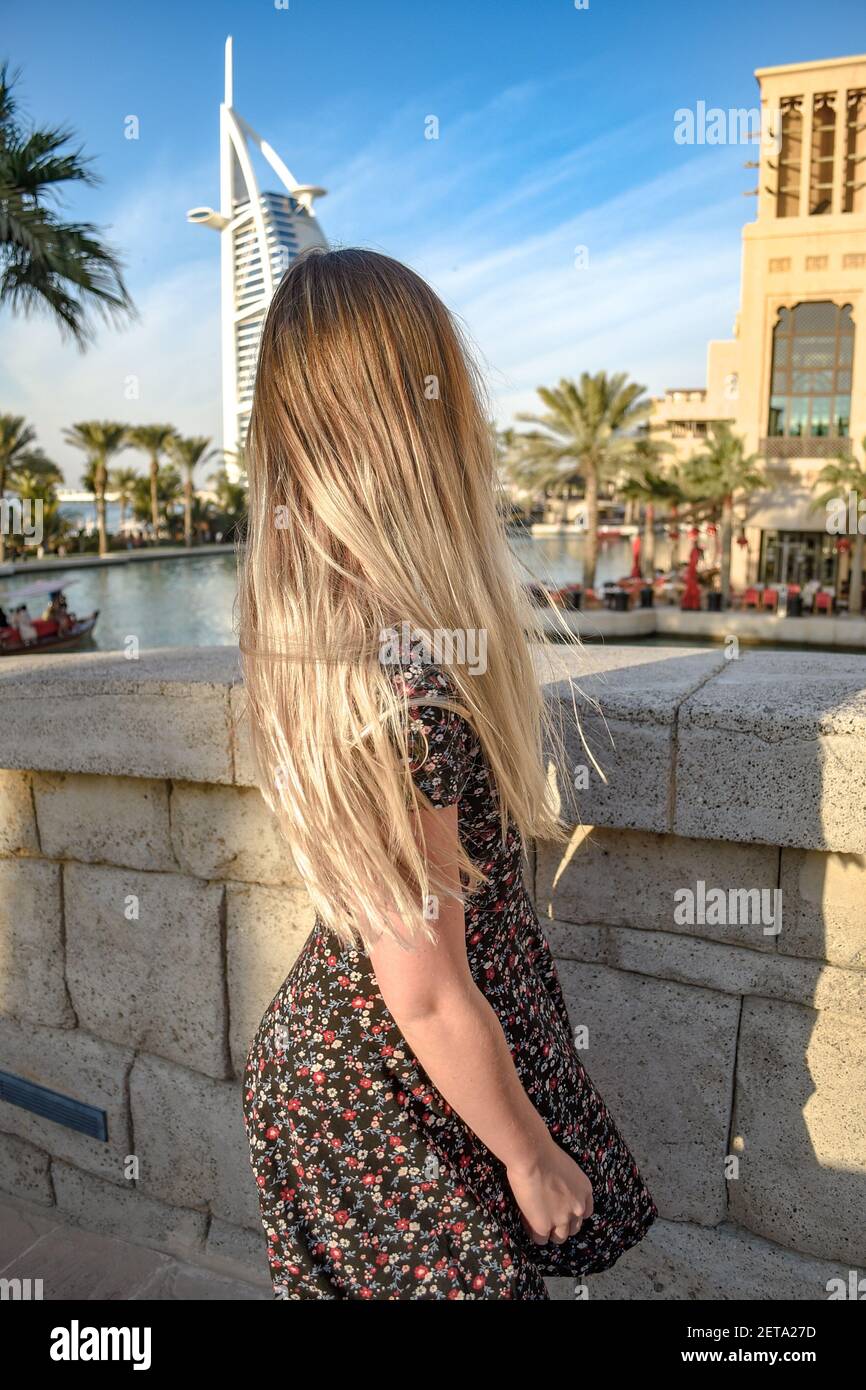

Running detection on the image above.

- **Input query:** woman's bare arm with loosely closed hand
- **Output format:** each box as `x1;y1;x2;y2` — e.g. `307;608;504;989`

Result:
361;805;592;1243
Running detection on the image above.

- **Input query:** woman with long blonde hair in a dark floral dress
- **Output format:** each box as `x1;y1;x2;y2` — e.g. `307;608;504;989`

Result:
240;250;657;1301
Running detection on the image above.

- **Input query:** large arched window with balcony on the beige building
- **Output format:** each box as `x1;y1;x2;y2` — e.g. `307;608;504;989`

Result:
767;300;853;439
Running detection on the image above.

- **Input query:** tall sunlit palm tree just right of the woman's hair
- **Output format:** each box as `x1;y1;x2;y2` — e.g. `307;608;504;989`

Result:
514;371;651;588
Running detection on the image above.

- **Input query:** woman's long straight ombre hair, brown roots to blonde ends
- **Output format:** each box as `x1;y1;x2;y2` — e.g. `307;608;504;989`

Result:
239;249;583;945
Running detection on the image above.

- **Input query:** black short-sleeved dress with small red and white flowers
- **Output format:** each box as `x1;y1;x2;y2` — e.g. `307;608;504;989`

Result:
243;662;657;1300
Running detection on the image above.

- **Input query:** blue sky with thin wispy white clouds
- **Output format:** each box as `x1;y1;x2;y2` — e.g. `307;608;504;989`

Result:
0;0;865;484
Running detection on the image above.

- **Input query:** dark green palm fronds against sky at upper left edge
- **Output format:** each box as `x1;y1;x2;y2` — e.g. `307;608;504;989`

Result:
0;64;135;348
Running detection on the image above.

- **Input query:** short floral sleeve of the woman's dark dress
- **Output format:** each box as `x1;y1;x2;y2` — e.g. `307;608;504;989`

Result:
403;667;478;806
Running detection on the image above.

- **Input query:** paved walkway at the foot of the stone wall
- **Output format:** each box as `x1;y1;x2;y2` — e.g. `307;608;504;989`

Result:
0;1197;274;1302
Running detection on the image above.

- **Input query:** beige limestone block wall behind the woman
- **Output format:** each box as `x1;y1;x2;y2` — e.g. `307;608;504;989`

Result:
0;648;866;1300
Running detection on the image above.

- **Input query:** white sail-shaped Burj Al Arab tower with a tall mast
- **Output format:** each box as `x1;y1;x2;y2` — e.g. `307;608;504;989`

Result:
186;38;328;480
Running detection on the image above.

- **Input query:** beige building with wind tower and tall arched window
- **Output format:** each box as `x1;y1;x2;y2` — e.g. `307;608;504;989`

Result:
652;56;866;592
